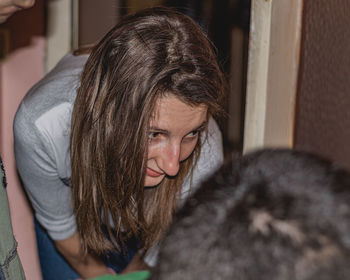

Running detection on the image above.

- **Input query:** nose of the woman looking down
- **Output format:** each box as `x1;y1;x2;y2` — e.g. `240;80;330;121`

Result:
157;143;181;176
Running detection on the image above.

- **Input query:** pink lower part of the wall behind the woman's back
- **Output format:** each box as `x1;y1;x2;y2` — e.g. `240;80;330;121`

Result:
0;37;45;280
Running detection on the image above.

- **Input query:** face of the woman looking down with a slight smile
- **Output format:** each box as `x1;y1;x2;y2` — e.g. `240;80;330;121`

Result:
145;94;208;187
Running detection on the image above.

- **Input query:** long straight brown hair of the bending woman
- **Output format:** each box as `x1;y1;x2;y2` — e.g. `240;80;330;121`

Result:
70;7;224;253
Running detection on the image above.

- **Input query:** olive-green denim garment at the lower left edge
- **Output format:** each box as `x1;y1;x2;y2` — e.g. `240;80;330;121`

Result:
0;158;25;280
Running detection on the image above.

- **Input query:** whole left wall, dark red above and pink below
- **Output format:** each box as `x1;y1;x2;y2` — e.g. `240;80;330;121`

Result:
0;0;45;280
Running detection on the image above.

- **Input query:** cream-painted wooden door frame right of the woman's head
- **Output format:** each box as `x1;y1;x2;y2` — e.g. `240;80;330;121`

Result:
243;0;303;153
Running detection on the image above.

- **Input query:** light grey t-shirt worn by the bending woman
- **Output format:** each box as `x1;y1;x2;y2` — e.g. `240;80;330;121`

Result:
14;54;223;243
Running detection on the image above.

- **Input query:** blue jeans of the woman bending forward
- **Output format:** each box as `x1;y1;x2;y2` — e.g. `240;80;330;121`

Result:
34;219;139;280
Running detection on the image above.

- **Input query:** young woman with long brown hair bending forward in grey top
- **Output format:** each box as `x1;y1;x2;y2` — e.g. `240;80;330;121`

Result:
14;8;224;280
